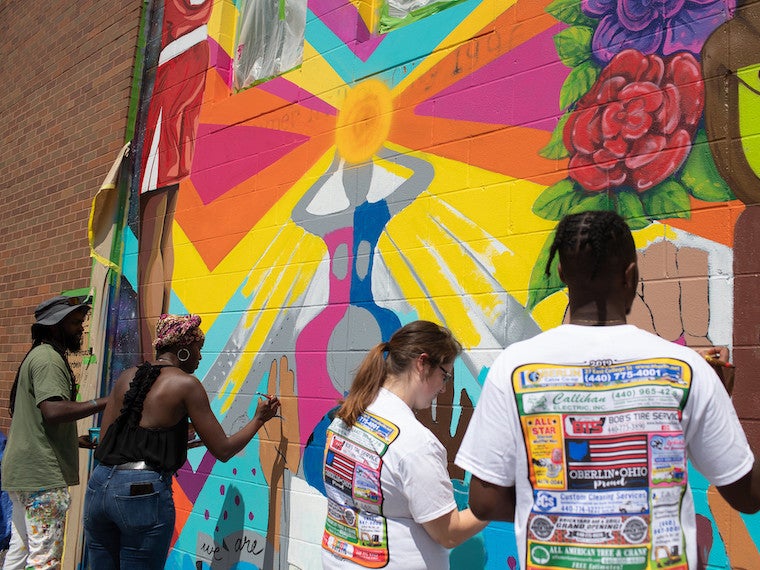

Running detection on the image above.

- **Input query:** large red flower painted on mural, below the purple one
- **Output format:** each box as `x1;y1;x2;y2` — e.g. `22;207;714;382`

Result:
563;49;704;192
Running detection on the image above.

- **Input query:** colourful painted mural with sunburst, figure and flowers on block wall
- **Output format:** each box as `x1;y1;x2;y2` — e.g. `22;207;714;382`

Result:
105;0;760;570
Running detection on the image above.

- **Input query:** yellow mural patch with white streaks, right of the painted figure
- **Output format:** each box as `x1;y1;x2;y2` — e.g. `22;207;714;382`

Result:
378;155;551;349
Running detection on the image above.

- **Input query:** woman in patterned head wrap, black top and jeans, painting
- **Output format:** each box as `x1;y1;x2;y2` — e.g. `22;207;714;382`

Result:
84;315;280;570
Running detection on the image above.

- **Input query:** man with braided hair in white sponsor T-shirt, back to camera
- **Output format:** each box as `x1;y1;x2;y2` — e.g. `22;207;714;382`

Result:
455;211;760;570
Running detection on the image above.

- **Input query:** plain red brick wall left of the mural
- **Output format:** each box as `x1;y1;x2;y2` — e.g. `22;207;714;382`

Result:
0;0;143;433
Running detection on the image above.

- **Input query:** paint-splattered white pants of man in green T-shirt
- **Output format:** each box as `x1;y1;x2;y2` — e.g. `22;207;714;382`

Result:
3;487;71;570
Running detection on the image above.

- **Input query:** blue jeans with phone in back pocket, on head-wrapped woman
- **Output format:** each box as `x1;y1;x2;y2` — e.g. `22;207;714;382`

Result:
84;465;174;570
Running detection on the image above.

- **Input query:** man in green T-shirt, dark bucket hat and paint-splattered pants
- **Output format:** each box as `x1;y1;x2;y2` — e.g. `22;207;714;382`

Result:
2;295;106;570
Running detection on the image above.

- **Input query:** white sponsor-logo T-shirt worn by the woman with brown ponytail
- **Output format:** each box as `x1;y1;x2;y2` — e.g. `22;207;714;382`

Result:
322;388;457;570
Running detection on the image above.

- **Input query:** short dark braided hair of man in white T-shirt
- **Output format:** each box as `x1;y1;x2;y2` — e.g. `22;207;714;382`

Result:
544;210;636;279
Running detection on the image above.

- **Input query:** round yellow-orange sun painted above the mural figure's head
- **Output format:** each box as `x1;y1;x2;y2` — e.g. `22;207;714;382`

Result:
335;79;393;163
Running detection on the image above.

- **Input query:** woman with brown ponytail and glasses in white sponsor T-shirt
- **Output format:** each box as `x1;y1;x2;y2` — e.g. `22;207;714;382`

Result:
322;321;486;570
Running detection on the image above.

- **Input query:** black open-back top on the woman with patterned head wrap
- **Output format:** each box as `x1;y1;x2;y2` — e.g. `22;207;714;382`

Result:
95;362;187;473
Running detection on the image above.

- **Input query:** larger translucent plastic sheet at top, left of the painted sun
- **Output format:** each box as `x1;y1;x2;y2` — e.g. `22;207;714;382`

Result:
234;0;306;89
